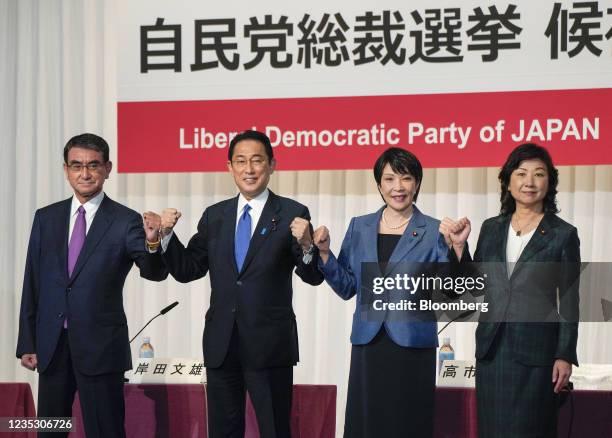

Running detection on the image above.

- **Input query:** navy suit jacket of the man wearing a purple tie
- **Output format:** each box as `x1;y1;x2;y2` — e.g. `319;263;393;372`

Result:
17;195;168;375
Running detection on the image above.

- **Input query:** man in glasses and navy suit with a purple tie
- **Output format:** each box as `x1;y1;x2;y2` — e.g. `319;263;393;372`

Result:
17;134;167;438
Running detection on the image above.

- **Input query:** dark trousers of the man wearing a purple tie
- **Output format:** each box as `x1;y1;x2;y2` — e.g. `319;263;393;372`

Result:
38;330;125;438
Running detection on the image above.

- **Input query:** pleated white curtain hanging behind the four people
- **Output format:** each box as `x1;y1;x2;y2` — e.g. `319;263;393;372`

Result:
0;0;612;436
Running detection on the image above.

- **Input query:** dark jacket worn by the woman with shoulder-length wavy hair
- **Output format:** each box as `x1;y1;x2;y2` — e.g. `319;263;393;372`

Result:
467;213;580;366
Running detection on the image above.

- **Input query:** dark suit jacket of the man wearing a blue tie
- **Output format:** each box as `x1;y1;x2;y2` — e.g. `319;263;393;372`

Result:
162;192;323;369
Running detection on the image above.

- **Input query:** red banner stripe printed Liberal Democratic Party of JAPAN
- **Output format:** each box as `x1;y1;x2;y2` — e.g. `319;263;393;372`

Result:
118;88;612;172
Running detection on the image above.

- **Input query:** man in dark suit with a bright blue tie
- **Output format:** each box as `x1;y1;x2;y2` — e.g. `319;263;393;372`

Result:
145;131;323;438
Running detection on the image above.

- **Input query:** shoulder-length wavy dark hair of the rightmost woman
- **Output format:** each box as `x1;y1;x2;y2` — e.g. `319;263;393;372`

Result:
499;143;559;215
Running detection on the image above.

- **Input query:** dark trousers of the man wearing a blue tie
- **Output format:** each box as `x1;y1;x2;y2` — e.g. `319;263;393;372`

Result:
206;325;293;438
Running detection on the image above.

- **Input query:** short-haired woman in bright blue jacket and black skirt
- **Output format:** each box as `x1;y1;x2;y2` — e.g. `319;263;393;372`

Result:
314;148;449;438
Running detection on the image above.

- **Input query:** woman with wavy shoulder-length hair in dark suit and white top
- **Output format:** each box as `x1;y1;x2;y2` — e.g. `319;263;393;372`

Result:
440;144;580;438
